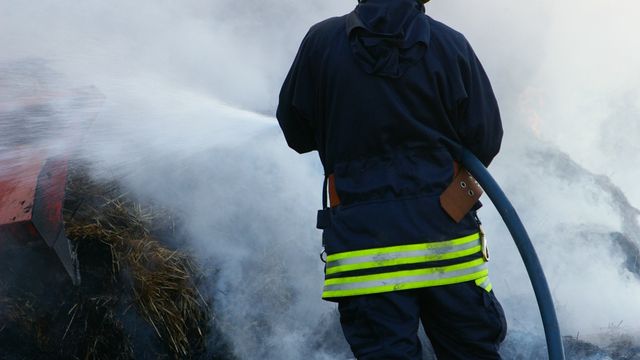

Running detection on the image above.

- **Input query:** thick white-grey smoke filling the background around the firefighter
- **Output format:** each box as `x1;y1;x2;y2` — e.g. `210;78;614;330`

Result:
0;0;640;359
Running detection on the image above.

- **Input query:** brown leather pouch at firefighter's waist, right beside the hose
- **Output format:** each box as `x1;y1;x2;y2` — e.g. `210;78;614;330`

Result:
440;167;483;223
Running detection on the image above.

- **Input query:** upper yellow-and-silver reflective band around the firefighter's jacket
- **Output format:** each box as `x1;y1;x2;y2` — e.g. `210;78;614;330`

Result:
326;238;482;274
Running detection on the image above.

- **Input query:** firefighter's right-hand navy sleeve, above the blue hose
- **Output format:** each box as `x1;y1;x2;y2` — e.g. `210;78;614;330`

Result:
456;45;503;166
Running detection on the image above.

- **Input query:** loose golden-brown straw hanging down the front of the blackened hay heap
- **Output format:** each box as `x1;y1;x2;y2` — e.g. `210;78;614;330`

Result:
65;166;211;358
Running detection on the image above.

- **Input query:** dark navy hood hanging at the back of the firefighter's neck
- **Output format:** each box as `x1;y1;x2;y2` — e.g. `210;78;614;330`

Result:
346;0;429;78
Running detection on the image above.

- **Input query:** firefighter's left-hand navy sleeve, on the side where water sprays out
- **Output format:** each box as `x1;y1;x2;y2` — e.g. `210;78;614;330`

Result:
276;32;317;154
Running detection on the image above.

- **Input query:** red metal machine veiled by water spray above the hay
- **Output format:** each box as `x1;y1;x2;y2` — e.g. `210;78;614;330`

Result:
0;67;104;285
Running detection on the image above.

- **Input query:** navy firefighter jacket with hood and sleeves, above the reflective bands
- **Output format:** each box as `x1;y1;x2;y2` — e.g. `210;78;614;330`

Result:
277;0;502;254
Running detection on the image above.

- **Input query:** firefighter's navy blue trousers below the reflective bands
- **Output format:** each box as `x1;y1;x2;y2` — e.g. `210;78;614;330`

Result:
338;281;507;360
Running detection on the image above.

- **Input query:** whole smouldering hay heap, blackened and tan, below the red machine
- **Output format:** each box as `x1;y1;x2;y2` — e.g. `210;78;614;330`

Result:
0;164;235;360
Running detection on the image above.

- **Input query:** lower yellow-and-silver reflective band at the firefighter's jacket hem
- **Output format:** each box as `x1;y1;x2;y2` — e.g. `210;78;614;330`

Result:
322;259;489;299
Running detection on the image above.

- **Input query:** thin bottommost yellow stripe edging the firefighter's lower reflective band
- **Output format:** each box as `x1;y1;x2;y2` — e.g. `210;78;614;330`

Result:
322;268;489;299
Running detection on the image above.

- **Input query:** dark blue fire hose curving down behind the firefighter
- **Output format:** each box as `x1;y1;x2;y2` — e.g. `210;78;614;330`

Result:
462;150;565;360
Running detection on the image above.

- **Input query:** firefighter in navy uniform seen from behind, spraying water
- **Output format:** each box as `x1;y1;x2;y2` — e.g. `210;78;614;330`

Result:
277;0;506;359
